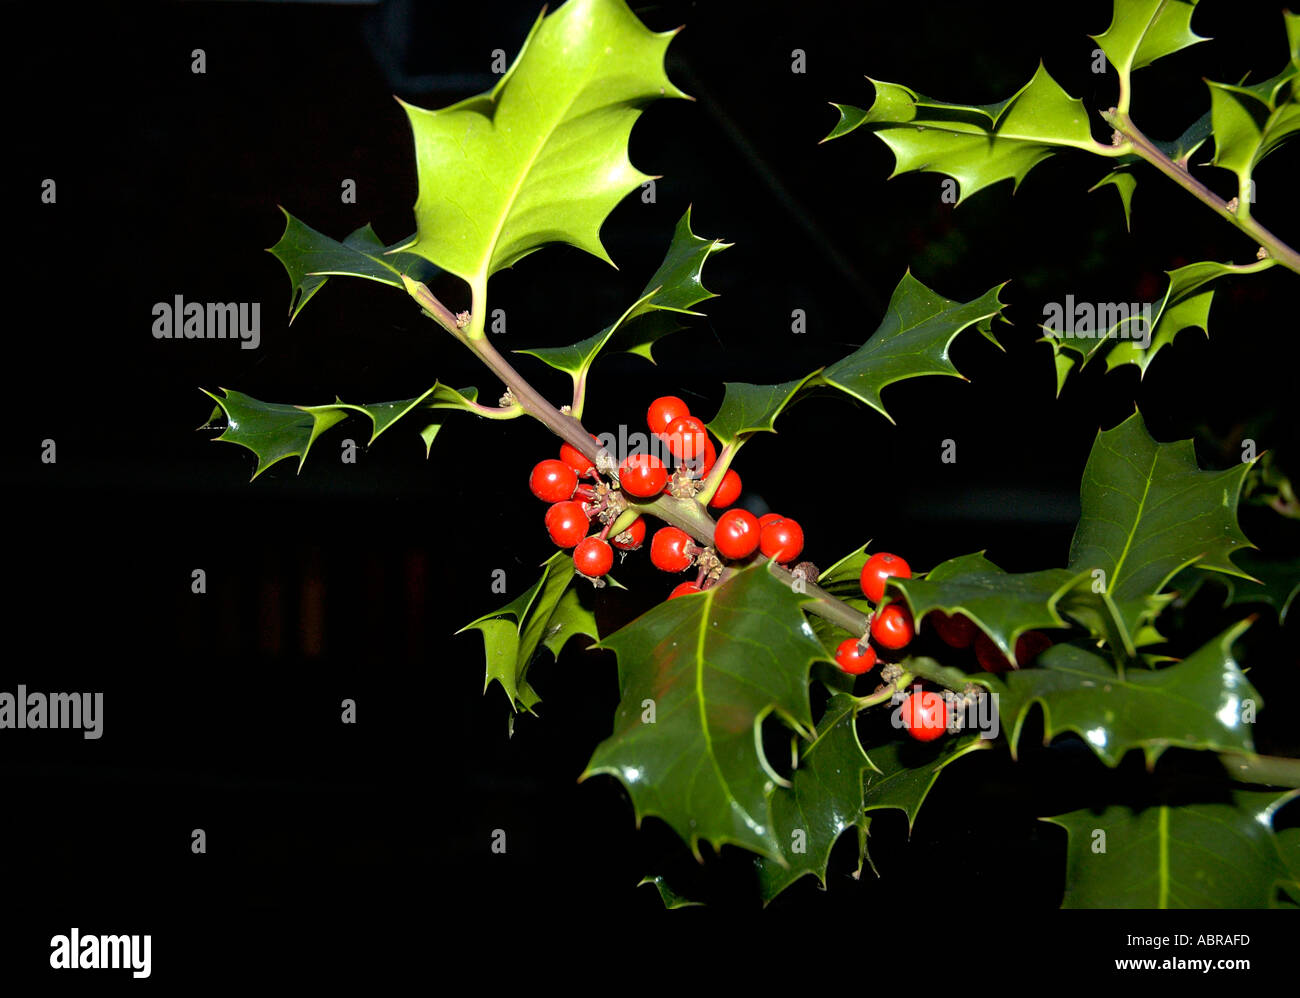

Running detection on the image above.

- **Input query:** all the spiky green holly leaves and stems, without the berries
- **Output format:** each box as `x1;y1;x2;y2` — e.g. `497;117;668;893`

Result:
202;0;1300;907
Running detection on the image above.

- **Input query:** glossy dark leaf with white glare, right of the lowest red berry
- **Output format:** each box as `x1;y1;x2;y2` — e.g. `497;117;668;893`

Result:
980;621;1262;768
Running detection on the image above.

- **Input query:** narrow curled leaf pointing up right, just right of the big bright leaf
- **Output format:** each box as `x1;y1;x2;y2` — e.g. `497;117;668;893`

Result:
515;208;731;384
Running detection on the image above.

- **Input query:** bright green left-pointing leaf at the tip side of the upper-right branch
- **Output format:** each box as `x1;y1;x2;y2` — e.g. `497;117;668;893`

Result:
827;62;1113;204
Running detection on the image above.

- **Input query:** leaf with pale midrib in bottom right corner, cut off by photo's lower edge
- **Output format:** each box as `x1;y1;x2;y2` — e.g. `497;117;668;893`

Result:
1043;790;1297;908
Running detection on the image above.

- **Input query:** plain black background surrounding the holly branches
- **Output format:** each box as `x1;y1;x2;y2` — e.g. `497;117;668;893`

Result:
0;3;1300;975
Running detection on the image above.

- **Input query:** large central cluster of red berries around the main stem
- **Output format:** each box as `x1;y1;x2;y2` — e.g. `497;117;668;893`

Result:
529;395;803;587
